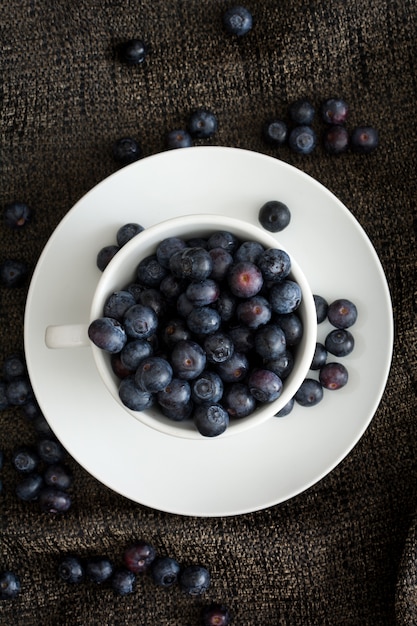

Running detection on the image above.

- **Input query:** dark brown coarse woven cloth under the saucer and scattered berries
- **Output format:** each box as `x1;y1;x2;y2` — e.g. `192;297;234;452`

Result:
0;0;417;626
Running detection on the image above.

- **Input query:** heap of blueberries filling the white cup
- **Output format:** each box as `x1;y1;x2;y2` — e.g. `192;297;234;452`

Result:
89;224;303;437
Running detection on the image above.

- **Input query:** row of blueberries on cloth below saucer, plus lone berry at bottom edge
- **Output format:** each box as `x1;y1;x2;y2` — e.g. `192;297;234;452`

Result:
57;540;230;625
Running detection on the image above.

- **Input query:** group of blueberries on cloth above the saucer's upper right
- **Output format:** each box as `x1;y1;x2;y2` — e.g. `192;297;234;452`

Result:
262;98;379;155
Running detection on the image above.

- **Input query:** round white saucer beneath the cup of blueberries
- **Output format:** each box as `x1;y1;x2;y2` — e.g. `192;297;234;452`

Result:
25;147;393;517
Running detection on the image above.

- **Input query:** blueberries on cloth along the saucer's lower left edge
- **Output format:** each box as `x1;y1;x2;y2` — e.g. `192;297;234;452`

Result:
0;353;72;513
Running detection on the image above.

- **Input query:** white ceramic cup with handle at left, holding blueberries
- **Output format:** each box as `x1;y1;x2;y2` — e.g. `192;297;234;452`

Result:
45;215;317;440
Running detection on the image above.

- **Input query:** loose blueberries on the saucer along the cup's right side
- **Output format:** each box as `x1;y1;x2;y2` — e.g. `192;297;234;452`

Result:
277;294;358;417
